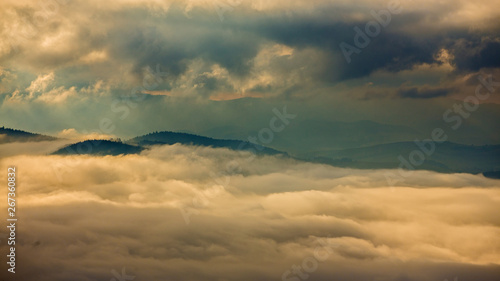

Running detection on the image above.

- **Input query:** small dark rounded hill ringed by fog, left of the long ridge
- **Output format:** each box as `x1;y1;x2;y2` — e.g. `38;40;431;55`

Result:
52;140;144;156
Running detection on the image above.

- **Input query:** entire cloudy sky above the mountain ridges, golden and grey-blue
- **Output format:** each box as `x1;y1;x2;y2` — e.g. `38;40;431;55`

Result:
0;0;500;151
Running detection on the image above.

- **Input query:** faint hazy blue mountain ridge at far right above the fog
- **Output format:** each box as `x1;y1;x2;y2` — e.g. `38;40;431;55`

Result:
309;142;500;174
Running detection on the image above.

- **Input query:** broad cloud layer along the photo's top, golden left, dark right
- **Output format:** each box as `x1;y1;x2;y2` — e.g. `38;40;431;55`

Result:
0;1;498;94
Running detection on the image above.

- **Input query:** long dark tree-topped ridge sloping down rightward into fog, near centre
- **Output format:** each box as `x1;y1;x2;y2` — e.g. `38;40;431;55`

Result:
127;131;287;155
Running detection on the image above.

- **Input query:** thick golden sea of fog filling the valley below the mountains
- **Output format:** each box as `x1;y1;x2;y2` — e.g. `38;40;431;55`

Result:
0;145;500;281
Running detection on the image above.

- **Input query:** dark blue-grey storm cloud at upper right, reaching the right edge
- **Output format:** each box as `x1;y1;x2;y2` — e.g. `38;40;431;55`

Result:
252;9;500;82
